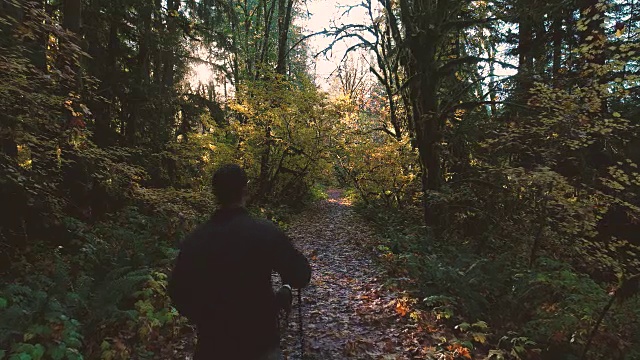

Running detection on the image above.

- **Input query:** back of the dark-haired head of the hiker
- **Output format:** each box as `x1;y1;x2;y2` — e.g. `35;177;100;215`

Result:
211;164;249;207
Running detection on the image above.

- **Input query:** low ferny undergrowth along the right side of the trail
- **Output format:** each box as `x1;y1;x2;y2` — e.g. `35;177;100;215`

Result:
356;203;640;359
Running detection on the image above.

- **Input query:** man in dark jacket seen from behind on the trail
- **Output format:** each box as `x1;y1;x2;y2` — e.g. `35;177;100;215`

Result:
169;164;311;360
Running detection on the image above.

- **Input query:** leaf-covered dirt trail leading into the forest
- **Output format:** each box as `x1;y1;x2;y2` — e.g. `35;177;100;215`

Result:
282;190;413;360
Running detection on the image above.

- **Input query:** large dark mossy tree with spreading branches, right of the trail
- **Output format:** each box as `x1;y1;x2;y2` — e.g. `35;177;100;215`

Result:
334;0;512;226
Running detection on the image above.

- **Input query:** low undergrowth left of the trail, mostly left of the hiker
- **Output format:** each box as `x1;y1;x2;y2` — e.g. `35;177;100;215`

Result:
0;184;319;360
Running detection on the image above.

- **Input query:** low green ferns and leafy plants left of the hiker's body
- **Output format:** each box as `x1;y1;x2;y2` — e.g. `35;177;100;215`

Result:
0;197;206;359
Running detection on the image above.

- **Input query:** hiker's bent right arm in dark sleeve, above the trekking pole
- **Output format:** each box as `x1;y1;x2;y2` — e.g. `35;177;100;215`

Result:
273;230;311;289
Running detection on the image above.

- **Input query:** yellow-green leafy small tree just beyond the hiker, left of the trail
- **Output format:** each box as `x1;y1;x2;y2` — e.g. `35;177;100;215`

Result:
231;78;337;206
